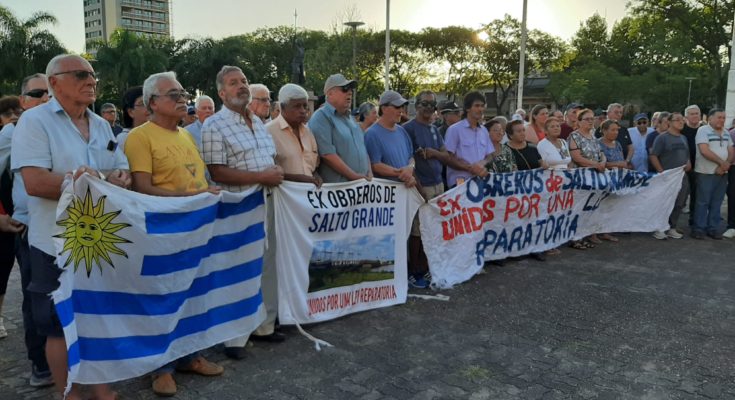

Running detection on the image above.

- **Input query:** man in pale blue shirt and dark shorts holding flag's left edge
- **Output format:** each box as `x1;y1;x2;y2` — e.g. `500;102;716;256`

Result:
11;54;130;399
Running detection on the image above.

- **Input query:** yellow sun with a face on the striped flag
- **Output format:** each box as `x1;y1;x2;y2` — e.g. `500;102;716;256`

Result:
54;188;132;277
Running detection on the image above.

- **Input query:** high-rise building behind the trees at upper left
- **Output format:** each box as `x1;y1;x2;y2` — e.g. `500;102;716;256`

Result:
83;0;171;53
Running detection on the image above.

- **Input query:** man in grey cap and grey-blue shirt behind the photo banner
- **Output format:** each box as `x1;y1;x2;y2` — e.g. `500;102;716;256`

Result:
309;74;373;183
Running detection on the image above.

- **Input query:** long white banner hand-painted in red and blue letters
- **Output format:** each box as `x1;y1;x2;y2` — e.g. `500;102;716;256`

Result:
419;168;684;288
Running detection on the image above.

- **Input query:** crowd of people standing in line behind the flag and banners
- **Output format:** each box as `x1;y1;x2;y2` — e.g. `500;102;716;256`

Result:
0;55;735;399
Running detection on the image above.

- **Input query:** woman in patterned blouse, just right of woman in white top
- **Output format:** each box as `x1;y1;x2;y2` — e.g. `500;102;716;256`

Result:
569;108;606;249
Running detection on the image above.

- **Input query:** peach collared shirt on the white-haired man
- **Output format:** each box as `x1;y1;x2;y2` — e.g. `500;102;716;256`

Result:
265;115;319;176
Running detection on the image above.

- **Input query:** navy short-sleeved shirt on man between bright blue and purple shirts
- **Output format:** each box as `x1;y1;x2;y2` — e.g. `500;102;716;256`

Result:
403;119;444;186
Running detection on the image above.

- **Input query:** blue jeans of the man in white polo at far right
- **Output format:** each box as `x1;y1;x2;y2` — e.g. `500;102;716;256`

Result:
693;173;727;234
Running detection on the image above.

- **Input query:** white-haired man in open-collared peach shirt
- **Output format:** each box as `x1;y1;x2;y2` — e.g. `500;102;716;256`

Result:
265;83;322;186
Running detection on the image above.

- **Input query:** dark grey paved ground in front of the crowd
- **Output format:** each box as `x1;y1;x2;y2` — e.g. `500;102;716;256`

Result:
0;230;735;400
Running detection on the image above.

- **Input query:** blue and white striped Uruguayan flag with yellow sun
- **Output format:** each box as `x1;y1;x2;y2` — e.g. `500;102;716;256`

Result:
53;175;265;384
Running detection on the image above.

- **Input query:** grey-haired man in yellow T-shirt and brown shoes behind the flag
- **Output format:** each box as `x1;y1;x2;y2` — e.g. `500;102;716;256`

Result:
125;72;223;396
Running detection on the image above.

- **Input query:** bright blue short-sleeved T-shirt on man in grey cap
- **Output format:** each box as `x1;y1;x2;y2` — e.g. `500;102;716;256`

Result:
365;123;413;180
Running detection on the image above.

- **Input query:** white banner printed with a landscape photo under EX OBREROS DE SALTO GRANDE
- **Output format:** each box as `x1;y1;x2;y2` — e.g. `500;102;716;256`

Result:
273;179;423;324
